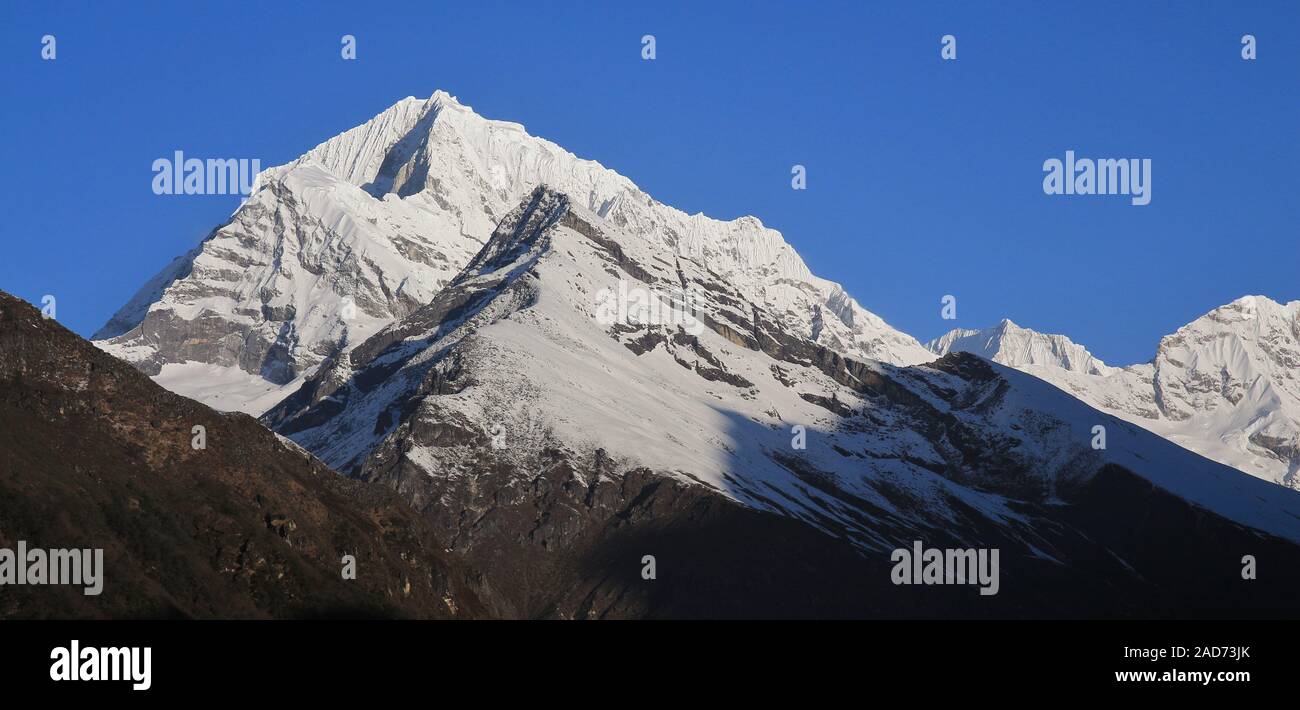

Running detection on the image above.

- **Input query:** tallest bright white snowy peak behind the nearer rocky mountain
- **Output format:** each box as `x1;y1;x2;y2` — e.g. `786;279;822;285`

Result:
94;91;933;414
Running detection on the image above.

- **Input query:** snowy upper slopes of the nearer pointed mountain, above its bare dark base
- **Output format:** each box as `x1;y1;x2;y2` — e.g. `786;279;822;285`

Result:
264;189;1300;548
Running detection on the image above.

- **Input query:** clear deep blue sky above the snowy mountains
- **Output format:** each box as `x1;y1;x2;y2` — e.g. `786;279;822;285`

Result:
0;0;1300;364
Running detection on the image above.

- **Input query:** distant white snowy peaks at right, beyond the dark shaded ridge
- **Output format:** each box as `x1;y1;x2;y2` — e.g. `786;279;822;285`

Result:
927;295;1300;489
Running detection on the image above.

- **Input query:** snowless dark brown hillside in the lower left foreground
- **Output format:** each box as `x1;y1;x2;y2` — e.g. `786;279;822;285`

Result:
0;293;489;619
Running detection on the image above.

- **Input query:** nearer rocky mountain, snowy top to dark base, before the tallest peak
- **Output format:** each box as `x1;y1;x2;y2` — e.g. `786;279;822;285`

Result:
264;189;1300;618
